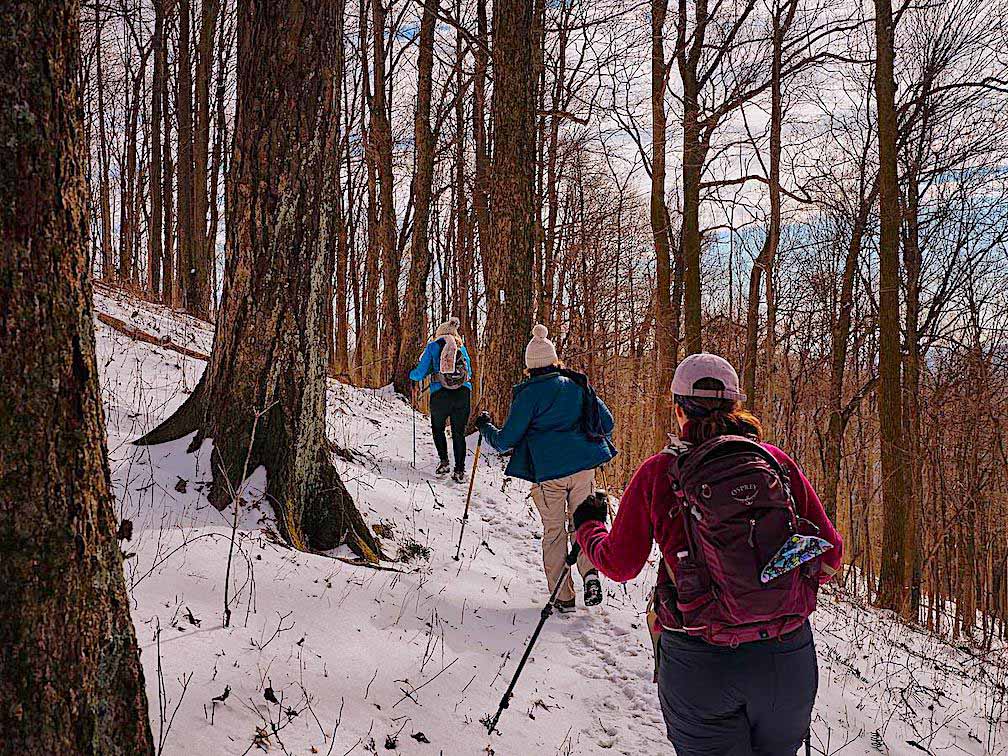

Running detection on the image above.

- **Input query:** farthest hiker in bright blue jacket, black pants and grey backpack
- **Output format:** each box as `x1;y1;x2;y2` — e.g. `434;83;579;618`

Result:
409;318;473;483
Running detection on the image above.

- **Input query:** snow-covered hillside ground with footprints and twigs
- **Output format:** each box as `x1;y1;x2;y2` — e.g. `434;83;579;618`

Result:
96;292;1008;756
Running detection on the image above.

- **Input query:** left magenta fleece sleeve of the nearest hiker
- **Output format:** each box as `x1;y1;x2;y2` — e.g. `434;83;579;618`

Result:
577;455;667;583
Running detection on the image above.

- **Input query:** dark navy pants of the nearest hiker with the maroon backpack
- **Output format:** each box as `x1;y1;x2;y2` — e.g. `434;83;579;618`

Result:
658;623;818;756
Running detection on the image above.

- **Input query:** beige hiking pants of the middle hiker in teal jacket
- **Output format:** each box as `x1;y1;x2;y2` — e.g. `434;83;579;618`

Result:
532;470;595;601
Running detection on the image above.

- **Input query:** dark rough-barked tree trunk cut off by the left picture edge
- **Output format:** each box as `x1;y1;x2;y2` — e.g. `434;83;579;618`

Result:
0;0;153;756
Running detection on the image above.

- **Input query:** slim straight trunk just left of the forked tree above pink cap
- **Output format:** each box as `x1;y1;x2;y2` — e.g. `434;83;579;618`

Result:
650;0;679;449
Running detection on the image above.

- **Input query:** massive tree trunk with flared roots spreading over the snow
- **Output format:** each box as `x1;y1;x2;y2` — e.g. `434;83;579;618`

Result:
139;0;380;559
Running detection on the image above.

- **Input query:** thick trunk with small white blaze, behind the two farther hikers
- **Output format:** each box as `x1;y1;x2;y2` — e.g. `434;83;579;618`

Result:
480;0;536;419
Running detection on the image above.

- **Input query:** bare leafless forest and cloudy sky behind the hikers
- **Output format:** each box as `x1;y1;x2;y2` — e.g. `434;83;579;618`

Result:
80;0;1008;643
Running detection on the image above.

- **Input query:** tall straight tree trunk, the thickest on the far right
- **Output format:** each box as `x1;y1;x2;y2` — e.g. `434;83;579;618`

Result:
875;0;912;612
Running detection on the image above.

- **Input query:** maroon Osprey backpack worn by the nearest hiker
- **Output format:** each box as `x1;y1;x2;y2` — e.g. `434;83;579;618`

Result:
655;435;821;646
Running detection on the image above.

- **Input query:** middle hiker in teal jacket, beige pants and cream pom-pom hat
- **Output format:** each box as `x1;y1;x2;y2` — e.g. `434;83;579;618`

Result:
476;325;617;612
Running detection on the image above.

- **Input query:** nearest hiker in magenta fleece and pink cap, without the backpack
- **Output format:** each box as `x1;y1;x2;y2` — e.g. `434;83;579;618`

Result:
574;354;843;756
